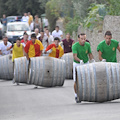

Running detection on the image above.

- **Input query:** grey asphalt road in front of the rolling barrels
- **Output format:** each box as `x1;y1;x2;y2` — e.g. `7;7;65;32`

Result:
0;80;120;120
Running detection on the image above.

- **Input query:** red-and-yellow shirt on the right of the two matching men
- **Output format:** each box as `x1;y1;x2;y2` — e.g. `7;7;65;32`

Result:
45;43;64;58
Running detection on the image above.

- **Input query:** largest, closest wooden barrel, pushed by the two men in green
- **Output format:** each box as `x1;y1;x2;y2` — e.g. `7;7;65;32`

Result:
76;62;120;102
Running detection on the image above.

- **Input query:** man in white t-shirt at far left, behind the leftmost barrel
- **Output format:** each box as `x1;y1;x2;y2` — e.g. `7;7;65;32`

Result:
0;36;12;56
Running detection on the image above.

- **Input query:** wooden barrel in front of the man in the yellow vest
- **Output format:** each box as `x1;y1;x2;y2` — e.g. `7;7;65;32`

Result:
14;57;29;83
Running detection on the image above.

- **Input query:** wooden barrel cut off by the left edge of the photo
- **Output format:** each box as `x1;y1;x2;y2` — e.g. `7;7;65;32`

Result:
0;54;13;80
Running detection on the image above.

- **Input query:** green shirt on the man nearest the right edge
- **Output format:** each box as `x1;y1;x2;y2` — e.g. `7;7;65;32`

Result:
97;39;119;62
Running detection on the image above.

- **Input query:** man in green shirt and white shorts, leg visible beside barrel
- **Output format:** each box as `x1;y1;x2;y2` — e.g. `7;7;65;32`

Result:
72;33;95;103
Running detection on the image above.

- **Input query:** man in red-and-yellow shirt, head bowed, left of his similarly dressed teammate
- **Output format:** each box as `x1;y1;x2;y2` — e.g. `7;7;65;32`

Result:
24;34;44;60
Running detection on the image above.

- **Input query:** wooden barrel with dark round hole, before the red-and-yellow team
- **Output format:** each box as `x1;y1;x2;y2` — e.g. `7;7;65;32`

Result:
29;56;66;87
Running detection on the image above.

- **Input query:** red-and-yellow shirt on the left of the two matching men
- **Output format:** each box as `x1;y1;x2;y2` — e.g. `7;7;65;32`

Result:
24;39;44;58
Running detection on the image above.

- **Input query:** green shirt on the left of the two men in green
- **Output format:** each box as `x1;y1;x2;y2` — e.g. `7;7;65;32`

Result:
72;42;91;63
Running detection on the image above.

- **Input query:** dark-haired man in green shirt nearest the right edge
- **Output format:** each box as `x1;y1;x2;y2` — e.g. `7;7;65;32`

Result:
97;31;120;62
